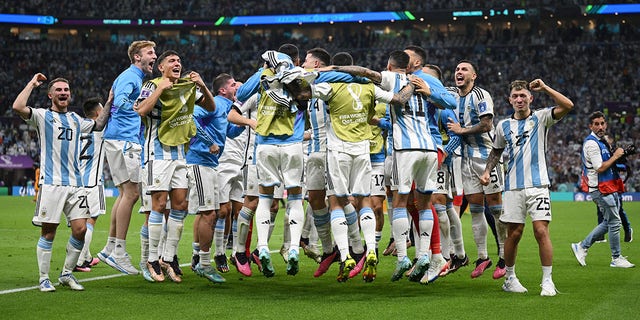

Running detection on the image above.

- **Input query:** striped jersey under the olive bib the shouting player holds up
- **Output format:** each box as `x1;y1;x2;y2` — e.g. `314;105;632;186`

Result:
137;81;185;161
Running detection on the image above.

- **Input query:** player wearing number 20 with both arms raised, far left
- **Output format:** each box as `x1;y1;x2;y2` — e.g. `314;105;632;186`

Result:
13;73;111;292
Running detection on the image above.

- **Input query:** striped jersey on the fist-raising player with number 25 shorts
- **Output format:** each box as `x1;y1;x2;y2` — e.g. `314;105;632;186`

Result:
493;108;558;190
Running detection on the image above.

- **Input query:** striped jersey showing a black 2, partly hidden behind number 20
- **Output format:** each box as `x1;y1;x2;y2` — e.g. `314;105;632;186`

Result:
80;131;104;187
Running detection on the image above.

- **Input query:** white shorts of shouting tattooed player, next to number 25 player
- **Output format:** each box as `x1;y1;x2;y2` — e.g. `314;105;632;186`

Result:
461;157;504;195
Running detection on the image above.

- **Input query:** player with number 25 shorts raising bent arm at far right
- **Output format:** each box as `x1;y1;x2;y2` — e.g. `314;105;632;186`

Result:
480;79;573;296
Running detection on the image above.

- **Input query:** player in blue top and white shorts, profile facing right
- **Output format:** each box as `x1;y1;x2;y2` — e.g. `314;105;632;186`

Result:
187;73;244;283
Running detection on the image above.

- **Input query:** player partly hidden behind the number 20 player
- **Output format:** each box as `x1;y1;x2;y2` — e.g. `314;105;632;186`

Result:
74;98;108;272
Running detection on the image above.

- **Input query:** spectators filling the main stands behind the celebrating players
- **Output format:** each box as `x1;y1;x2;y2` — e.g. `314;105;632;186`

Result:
0;10;640;191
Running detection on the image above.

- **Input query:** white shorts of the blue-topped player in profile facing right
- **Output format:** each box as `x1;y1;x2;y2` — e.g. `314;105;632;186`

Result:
187;164;220;214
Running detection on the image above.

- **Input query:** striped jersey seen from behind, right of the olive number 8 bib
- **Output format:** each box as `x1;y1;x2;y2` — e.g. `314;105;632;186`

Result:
381;71;437;151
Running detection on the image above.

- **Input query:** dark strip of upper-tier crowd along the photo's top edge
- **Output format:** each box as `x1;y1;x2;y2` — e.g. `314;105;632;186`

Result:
0;0;612;19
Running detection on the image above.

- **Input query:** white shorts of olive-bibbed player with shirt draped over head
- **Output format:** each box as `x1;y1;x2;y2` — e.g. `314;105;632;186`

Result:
256;143;304;189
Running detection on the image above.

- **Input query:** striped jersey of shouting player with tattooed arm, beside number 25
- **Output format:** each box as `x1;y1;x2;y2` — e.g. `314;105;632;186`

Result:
458;86;493;160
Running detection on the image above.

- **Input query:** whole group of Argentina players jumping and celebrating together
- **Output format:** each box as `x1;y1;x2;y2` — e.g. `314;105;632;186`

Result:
13;41;586;296
